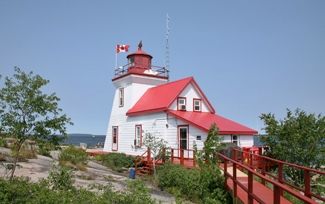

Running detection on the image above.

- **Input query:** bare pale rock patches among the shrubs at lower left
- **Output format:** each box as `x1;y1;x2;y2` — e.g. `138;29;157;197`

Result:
0;148;175;203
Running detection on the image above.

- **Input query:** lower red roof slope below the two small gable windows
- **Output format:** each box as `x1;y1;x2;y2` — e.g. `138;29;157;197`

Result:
167;110;257;135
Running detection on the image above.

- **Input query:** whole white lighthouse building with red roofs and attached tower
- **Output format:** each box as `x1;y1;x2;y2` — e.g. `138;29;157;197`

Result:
104;43;257;155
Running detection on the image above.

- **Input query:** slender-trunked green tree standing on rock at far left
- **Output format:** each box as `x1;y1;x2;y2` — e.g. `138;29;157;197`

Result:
0;67;72;180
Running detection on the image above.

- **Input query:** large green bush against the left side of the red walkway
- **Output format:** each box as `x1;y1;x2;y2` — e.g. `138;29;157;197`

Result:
157;163;227;203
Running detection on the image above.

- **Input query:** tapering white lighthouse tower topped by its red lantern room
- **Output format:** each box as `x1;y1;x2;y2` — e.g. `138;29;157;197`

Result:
104;42;169;154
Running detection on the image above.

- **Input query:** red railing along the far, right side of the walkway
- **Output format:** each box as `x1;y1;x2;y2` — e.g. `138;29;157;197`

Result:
232;149;325;202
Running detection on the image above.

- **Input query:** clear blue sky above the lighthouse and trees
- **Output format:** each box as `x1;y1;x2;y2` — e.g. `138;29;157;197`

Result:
0;0;325;134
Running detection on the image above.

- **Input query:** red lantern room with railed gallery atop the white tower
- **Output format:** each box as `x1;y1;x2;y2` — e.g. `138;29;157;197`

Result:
113;41;169;81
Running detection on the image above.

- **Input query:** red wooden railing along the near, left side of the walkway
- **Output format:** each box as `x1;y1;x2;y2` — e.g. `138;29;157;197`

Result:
218;153;316;204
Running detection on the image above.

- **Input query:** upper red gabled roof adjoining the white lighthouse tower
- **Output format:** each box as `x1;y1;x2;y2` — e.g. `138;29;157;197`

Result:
126;77;214;115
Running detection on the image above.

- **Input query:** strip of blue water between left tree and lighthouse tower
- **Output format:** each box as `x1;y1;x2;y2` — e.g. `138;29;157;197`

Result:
63;134;105;148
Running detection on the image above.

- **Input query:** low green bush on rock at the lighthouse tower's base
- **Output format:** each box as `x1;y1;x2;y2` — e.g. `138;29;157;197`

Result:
96;153;134;172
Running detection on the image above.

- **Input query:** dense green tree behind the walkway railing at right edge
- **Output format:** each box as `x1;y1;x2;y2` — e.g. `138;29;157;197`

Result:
260;109;325;183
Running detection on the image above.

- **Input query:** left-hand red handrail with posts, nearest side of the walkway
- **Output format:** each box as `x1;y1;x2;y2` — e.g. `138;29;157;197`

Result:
217;153;316;204
